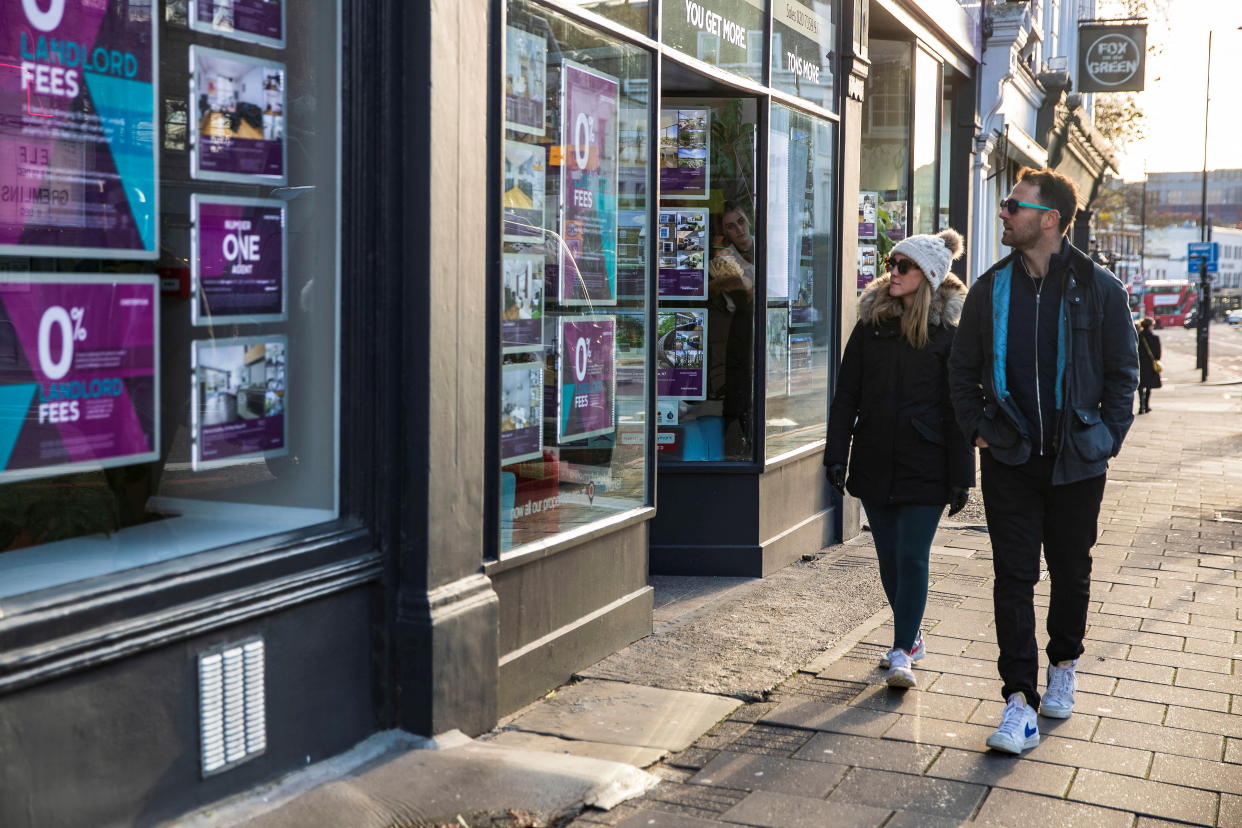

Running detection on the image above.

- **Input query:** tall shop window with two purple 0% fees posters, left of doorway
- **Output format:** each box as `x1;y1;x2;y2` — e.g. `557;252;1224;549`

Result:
496;1;652;554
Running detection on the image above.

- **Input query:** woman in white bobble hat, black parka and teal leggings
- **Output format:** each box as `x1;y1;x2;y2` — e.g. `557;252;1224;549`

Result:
823;230;975;688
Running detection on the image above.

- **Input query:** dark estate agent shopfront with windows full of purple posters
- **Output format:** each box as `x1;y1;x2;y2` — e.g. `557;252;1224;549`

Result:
0;0;982;826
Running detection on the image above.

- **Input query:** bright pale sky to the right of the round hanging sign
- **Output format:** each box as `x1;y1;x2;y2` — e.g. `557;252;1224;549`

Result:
1118;0;1242;181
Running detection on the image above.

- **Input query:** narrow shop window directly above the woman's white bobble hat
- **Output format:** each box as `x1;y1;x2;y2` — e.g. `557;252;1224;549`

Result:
857;40;912;290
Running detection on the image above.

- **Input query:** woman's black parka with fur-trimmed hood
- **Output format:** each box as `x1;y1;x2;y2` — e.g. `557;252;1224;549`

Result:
823;274;975;505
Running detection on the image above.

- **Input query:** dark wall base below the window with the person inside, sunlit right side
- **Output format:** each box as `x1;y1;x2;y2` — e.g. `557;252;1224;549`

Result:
651;451;836;577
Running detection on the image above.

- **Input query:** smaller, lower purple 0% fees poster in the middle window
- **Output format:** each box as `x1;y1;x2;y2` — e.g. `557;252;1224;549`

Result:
556;317;616;443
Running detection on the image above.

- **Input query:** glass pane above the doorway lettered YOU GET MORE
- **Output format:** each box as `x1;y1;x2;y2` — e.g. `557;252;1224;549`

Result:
661;0;768;81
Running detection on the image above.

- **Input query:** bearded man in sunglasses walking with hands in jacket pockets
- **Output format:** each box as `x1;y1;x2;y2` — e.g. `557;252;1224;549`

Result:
949;168;1138;754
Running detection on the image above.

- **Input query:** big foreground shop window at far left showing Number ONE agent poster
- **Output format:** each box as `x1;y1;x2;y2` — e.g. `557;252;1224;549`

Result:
0;0;340;596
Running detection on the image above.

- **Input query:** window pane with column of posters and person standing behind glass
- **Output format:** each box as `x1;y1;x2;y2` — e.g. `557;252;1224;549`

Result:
656;98;761;463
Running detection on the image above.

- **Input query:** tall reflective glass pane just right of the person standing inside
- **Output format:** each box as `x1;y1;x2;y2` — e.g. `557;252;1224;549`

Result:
765;104;837;459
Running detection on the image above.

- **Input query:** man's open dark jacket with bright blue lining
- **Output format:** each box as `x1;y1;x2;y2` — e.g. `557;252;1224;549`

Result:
949;242;1139;485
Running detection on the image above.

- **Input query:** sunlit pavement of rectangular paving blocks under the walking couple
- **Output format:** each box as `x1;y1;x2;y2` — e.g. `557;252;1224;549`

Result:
573;355;1242;828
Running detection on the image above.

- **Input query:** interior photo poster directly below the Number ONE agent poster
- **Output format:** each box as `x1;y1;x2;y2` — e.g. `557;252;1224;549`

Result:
190;335;289;470
